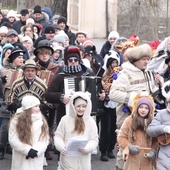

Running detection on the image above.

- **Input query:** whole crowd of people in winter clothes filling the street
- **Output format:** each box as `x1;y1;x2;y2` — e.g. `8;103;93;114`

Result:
0;5;170;170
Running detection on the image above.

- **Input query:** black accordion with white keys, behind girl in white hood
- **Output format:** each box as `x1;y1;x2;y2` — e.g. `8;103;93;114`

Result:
64;76;101;115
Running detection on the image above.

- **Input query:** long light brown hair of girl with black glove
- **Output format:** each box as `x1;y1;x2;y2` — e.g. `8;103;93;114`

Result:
16;109;49;145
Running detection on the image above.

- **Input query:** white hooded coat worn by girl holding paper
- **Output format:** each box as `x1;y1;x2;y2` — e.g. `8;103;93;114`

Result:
54;92;98;170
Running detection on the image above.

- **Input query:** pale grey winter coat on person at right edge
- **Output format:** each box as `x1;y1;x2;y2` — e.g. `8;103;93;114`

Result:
146;109;170;170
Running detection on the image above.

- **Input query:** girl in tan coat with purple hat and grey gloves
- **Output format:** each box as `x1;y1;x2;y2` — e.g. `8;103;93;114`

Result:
118;92;157;170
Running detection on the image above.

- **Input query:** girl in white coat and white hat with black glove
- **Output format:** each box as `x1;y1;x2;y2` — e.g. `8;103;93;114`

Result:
9;95;49;170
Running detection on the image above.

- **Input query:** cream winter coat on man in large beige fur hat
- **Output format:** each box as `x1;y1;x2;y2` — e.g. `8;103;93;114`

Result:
109;62;158;128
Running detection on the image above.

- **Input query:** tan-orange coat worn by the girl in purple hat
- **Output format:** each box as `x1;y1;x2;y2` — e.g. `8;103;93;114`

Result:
117;116;157;170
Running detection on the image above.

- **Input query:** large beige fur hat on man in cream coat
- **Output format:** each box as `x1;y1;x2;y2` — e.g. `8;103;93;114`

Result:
124;44;152;63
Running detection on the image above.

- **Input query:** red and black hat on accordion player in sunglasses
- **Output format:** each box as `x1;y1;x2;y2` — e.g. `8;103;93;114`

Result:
64;46;81;65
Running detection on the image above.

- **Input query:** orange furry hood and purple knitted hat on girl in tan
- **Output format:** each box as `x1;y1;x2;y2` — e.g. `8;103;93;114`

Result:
132;91;155;116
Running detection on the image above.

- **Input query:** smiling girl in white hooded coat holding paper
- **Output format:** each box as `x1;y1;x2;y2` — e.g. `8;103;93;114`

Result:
54;92;98;170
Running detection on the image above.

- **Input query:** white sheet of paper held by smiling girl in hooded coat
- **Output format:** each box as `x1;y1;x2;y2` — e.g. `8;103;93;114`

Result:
66;136;88;157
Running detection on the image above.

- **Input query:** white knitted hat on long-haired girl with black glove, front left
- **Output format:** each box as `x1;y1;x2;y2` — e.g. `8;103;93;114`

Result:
21;95;40;110
